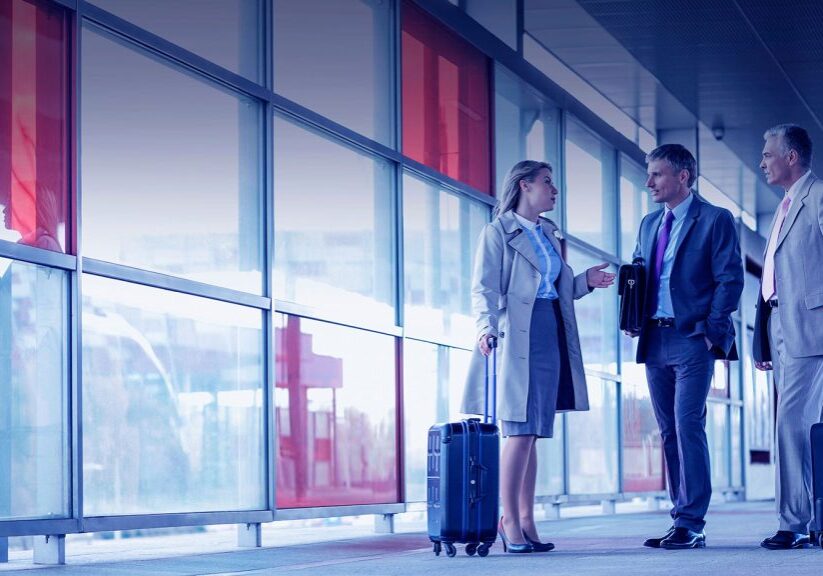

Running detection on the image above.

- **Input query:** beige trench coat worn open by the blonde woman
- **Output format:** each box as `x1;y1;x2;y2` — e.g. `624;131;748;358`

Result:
462;211;591;422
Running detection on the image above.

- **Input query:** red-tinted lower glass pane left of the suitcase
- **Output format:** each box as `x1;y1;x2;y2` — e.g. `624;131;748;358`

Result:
275;314;399;508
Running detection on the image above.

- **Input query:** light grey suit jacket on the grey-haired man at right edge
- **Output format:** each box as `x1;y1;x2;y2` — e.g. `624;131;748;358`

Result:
752;174;823;362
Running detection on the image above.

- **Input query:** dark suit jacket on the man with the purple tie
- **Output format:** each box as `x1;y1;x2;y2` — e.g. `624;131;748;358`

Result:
634;194;743;362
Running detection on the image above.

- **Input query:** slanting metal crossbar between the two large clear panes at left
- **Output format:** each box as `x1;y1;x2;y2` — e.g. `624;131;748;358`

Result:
82;258;271;310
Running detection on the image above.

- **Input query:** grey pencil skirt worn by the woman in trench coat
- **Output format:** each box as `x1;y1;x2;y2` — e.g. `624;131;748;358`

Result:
501;298;560;438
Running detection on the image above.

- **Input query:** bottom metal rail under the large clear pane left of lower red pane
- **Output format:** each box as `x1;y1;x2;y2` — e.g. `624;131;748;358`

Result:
84;510;274;532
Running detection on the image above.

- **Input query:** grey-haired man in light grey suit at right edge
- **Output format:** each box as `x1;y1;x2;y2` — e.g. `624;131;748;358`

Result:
753;124;823;550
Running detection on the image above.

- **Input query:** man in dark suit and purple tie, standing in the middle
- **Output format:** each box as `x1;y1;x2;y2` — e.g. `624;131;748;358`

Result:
629;144;743;550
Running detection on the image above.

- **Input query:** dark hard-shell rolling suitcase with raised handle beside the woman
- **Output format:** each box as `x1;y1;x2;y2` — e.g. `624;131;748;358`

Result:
426;339;500;557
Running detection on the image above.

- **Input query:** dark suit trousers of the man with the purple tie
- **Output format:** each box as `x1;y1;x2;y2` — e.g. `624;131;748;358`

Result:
646;326;714;531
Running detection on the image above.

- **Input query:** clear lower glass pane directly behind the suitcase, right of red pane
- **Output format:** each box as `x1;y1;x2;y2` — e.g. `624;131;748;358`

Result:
403;339;471;502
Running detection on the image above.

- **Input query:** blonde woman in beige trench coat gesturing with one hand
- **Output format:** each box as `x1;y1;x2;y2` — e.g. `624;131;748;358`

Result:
463;160;614;553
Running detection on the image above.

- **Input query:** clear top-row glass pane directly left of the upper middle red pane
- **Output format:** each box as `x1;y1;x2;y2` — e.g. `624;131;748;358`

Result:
274;0;395;146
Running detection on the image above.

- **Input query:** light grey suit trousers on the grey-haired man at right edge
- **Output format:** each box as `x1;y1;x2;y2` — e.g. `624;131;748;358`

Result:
769;308;823;534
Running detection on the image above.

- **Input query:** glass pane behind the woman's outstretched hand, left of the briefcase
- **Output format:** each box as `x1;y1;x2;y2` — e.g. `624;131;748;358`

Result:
567;244;618;374
